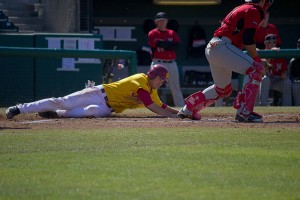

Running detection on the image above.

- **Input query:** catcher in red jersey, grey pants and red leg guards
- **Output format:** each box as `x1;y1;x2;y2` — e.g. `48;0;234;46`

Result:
178;0;273;122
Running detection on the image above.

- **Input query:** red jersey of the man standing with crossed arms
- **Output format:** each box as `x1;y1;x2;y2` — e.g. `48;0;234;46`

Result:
148;28;181;60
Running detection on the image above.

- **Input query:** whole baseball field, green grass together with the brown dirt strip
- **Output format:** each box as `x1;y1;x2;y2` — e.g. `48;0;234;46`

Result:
0;107;300;200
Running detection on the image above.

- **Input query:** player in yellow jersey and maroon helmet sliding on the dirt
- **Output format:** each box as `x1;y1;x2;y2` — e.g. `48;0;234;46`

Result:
6;65;178;119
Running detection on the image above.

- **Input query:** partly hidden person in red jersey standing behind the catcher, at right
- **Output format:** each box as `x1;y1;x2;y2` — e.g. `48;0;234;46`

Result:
255;12;281;49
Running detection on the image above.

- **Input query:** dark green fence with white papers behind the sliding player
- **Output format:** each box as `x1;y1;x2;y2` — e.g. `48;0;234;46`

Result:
0;34;137;107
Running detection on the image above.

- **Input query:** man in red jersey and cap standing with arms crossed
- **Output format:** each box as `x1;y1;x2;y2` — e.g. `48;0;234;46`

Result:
148;12;184;107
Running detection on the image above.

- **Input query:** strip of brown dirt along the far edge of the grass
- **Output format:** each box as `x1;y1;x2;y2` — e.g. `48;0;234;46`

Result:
0;112;300;131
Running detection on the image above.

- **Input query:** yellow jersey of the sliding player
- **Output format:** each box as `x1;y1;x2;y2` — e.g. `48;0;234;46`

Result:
103;73;162;113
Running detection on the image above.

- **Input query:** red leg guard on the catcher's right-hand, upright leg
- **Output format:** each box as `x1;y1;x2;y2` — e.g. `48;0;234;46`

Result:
234;62;264;115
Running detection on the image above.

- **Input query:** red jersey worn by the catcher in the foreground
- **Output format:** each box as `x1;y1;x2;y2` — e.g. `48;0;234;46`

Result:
214;3;265;49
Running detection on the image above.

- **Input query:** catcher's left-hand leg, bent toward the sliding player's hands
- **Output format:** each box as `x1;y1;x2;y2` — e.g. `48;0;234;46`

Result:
179;38;240;116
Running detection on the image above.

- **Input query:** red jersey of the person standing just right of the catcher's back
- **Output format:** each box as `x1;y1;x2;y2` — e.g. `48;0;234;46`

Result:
255;24;281;49
